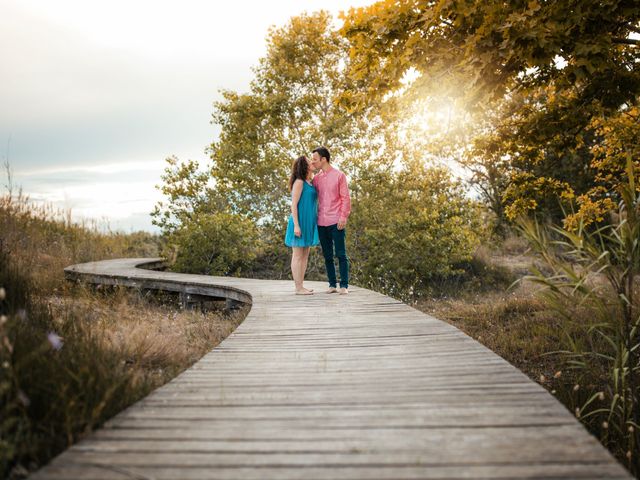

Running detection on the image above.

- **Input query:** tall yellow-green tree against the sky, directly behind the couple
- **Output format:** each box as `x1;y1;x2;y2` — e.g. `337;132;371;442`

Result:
209;12;374;227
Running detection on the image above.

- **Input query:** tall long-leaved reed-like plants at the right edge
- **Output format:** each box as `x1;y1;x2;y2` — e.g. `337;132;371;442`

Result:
521;158;640;473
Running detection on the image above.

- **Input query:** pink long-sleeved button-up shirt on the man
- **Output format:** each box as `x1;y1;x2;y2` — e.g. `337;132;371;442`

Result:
313;167;351;227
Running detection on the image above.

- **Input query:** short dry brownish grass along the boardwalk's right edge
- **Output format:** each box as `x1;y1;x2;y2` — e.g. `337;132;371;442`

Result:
416;252;629;474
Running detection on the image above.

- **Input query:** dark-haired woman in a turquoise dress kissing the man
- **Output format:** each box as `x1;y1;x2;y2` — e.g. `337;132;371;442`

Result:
284;155;320;295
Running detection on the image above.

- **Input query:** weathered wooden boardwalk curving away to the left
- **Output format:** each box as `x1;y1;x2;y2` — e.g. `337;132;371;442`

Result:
32;259;631;480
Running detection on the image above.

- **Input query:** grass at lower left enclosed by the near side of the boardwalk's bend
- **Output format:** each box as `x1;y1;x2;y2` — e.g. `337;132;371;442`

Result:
0;287;248;479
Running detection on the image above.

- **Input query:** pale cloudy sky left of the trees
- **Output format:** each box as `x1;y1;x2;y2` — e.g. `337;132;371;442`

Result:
0;0;373;232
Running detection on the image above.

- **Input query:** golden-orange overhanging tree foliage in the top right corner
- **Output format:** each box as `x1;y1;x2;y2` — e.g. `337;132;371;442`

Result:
342;0;640;224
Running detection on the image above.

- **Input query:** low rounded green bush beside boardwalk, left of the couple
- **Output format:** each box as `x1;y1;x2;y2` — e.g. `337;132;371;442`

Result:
172;212;260;275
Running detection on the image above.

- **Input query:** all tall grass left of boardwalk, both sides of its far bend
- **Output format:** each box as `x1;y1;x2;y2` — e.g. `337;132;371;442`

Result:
0;189;245;478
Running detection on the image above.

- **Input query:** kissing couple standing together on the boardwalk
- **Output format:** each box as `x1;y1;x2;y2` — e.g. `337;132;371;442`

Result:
284;147;351;295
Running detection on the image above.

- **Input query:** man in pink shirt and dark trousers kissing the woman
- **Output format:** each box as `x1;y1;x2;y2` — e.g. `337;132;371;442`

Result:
311;147;351;295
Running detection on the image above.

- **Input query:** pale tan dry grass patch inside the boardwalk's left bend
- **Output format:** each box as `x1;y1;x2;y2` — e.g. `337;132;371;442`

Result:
46;287;249;382
